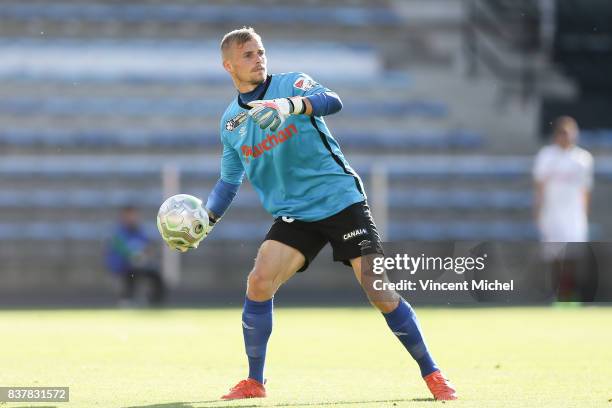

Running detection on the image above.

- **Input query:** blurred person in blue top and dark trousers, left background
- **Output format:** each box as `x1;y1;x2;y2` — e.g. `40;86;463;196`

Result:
106;206;166;306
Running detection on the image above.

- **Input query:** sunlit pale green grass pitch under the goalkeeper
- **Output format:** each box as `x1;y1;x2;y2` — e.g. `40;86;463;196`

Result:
0;305;612;408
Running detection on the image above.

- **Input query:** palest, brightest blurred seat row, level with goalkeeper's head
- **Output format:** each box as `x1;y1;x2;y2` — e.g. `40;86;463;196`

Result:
0;38;404;83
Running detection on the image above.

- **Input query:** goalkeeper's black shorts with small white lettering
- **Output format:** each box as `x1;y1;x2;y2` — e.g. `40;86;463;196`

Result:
265;201;383;272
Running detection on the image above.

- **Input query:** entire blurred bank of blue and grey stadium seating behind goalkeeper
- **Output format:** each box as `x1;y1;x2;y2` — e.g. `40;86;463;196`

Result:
0;0;612;290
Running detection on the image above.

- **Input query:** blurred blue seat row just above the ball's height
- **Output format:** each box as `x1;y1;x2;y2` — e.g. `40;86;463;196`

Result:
0;155;612;182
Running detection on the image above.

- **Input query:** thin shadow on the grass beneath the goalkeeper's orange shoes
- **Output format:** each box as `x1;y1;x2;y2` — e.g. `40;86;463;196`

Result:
125;398;435;408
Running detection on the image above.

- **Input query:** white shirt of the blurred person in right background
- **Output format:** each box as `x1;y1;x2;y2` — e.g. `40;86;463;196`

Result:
533;144;593;242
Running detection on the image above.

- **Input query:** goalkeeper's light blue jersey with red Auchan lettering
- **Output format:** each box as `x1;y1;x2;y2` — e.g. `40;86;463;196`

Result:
220;72;366;221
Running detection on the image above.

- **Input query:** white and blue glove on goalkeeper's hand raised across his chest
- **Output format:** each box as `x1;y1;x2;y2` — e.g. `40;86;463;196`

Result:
248;96;306;131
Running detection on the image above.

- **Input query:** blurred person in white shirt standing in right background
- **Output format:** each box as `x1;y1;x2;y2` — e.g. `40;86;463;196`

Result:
533;116;593;300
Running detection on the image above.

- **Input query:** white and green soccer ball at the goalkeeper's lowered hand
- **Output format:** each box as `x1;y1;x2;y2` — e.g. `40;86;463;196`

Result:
157;194;208;249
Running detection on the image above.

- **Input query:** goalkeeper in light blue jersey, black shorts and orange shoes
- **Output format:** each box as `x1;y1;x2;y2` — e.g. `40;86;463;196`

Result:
180;28;456;400
